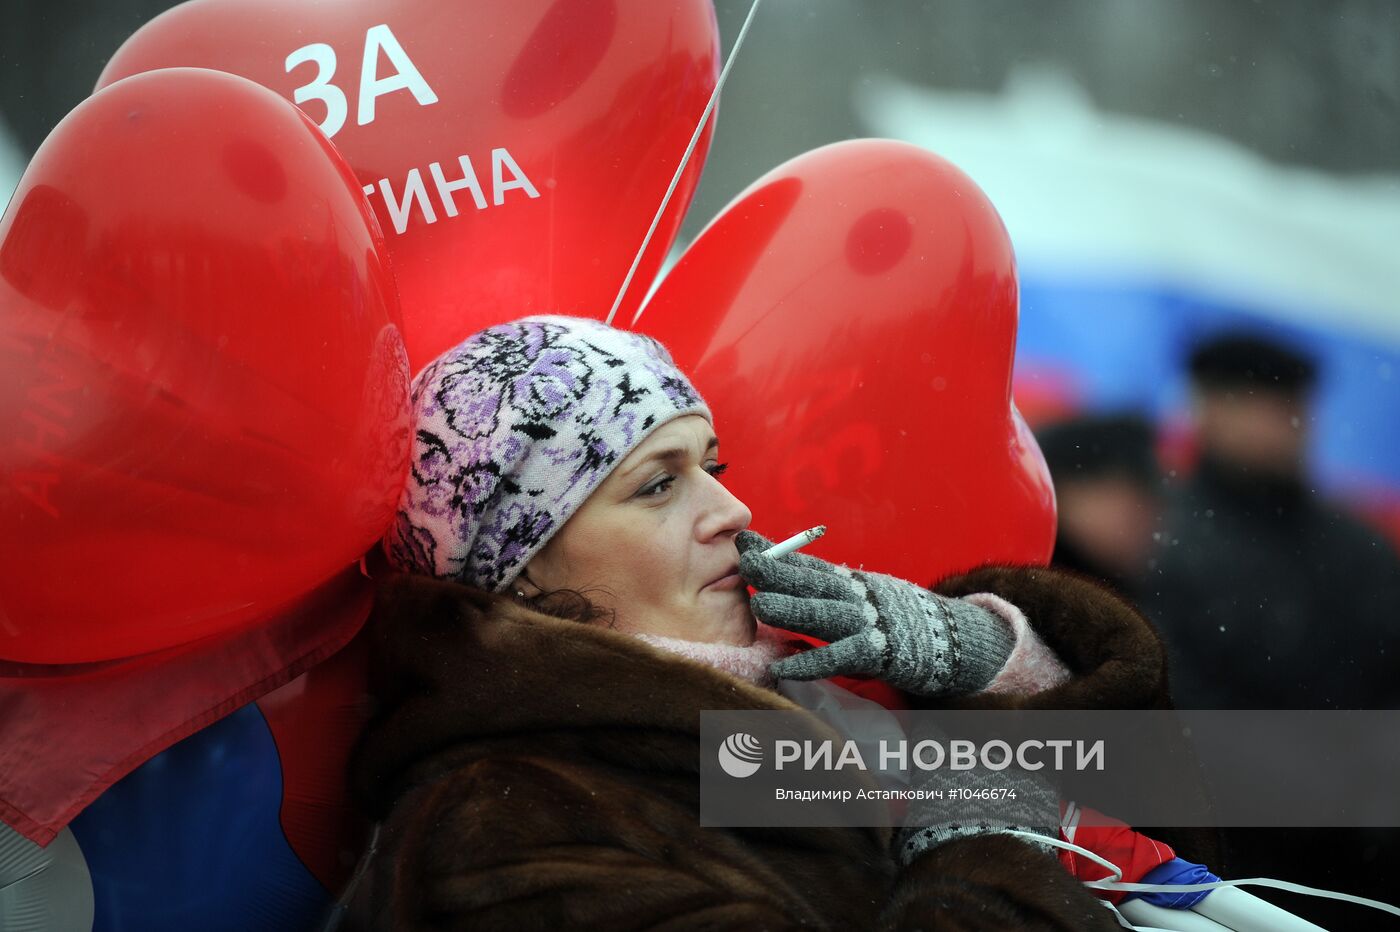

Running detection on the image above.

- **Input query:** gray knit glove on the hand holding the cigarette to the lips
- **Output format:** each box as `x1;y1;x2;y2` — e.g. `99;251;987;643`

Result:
735;530;1015;696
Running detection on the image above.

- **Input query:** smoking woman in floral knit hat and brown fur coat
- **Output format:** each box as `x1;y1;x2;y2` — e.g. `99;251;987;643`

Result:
351;318;1166;929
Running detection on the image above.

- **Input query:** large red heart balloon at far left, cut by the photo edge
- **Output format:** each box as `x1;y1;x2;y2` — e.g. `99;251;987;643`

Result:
0;69;409;663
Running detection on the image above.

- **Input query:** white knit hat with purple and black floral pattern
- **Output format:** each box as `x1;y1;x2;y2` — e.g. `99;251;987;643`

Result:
384;316;710;592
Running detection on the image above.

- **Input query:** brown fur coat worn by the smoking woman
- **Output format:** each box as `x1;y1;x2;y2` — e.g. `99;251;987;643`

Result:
350;568;1166;932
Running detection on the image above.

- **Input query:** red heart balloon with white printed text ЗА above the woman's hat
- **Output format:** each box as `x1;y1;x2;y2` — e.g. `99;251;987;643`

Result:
98;0;718;371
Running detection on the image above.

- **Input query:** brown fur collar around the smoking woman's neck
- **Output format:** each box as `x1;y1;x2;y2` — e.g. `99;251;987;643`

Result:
353;575;818;812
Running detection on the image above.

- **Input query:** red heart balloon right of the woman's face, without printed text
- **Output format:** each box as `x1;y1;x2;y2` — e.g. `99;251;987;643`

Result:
637;140;1054;582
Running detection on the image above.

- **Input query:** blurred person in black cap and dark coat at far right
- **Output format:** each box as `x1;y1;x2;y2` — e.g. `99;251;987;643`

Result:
1145;333;1400;709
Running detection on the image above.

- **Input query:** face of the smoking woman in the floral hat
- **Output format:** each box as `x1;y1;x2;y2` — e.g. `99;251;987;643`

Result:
514;414;755;644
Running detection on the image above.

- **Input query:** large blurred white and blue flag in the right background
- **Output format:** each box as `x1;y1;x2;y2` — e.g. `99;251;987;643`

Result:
858;69;1400;542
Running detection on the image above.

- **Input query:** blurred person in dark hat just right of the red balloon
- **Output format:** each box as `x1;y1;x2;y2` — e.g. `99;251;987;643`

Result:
1036;414;1162;602
